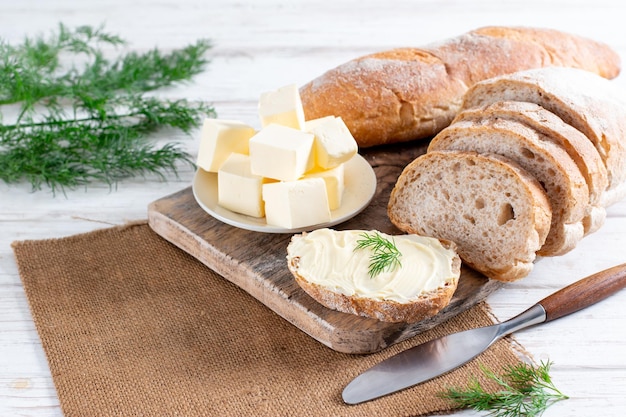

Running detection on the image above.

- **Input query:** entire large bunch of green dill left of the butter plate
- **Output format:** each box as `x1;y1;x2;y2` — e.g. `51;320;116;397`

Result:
0;24;215;191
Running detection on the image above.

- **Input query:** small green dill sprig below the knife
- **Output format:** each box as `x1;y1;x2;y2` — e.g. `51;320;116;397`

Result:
441;362;568;417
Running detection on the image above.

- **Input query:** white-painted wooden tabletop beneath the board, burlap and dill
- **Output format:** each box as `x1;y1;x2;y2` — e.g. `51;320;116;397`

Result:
0;0;626;417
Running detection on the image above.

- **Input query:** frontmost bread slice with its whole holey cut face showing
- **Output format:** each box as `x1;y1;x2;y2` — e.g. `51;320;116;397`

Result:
388;151;552;281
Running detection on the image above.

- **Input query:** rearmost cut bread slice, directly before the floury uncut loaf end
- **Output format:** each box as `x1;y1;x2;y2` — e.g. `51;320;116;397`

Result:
452;101;608;235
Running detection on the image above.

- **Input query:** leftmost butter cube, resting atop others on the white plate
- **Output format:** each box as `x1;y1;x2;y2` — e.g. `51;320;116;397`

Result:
197;119;255;172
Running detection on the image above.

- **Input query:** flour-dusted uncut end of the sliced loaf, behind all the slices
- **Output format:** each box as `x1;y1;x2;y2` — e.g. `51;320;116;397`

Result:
461;67;626;207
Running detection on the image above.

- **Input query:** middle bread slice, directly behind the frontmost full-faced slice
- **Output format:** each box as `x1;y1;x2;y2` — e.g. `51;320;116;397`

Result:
428;118;589;256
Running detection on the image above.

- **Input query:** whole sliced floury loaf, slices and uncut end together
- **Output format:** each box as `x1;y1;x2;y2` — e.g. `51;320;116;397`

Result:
388;68;626;281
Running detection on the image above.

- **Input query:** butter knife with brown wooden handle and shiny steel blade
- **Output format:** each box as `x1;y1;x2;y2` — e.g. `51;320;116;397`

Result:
342;263;626;404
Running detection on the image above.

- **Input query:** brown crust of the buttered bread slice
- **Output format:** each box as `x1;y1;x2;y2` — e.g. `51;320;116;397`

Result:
287;232;461;323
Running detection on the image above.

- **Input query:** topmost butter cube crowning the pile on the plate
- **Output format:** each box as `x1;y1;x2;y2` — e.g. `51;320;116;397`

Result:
259;84;304;130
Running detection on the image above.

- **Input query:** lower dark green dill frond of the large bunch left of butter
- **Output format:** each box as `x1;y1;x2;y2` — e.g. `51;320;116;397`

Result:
0;97;209;191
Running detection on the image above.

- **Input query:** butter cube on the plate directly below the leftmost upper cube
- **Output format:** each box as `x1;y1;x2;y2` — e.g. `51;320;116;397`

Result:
217;153;266;217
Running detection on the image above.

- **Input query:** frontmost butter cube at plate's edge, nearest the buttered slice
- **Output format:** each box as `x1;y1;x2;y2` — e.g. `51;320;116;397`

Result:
263;178;331;229
